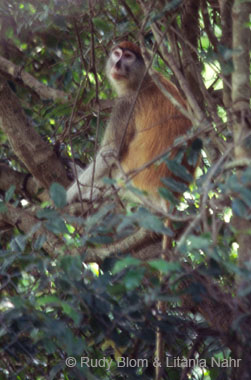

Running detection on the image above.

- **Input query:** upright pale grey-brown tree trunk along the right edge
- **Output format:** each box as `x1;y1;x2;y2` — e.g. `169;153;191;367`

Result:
232;0;251;380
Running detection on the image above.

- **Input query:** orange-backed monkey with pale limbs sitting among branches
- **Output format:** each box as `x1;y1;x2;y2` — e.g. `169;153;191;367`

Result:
67;41;195;209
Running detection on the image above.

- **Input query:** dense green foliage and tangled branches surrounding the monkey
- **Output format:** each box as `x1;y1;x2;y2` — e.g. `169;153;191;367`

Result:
0;0;251;380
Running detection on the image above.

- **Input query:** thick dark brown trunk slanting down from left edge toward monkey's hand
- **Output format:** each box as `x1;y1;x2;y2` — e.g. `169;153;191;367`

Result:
0;82;70;189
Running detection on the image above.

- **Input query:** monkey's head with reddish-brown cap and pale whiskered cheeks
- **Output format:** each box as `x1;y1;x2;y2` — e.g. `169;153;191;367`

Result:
106;41;145;95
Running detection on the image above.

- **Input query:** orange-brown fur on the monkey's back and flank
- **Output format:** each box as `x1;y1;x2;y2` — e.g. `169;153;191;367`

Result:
122;76;191;202
